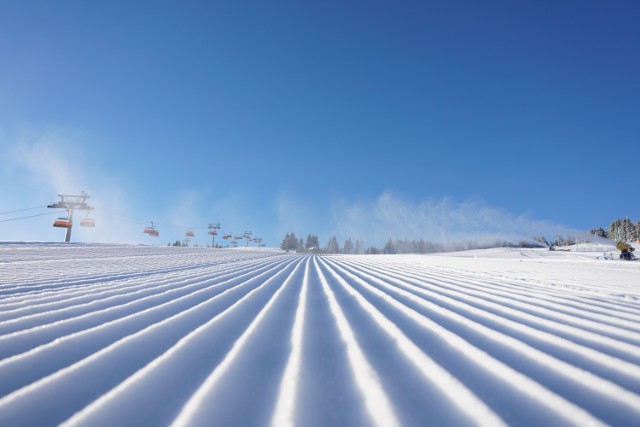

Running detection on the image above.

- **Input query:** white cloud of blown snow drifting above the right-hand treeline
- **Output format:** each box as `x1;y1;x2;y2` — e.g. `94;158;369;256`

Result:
333;191;594;249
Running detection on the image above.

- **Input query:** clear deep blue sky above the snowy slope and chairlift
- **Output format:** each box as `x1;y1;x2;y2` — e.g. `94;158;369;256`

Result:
0;0;640;245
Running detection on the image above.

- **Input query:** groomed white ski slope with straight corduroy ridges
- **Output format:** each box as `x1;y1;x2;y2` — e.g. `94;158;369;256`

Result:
0;243;640;426
